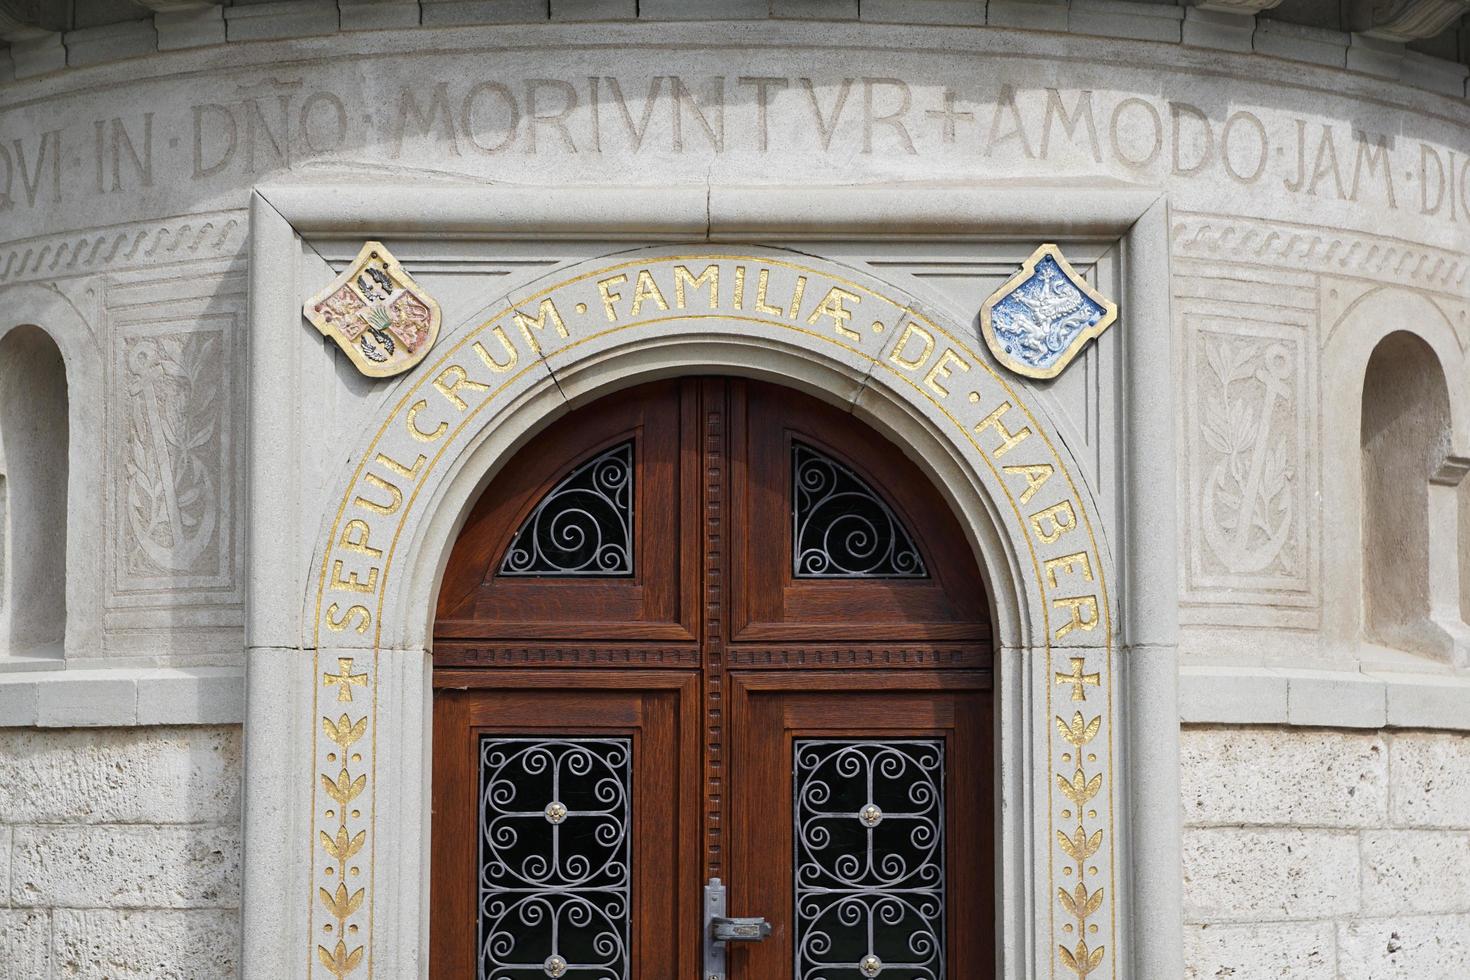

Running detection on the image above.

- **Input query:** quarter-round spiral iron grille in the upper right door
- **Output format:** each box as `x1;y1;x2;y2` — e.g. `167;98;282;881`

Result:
791;442;929;579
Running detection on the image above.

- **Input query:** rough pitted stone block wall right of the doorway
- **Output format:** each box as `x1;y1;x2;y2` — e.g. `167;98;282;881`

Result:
1182;726;1470;980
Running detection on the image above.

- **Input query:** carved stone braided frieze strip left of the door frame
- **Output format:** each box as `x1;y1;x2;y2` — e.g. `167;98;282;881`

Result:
0;212;245;284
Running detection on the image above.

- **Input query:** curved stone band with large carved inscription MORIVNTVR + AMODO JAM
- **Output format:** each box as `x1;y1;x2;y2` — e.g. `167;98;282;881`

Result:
0;58;1470;240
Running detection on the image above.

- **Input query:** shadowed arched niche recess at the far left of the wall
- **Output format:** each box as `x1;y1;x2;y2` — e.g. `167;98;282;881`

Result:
0;325;71;657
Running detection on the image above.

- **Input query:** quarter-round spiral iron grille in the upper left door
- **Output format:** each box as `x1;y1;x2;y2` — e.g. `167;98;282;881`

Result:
500;441;634;577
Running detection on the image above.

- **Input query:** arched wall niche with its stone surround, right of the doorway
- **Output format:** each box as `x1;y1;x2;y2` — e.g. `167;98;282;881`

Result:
1323;288;1470;666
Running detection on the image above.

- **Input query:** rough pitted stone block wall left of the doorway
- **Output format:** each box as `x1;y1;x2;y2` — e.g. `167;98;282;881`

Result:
0;727;241;980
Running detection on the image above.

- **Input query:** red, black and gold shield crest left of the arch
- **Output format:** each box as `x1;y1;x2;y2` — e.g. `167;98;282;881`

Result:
301;241;440;378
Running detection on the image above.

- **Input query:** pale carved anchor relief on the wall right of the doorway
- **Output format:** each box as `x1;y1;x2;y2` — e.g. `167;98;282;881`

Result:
1200;335;1295;574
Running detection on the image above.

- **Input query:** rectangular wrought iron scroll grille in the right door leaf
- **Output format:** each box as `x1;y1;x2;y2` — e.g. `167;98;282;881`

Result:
794;739;945;980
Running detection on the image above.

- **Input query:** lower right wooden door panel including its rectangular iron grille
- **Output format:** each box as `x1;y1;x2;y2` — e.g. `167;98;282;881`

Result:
729;671;995;980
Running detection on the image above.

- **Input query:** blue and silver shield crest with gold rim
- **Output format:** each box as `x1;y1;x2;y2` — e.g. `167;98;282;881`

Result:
980;244;1117;378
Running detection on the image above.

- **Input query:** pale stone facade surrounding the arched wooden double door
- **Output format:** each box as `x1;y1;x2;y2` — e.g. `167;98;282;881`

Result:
0;0;1470;980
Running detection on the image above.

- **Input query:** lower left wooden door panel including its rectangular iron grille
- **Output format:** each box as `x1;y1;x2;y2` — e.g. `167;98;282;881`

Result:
429;671;700;980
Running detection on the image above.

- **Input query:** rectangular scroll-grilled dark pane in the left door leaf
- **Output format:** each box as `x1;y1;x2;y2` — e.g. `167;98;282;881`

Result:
478;736;632;980
